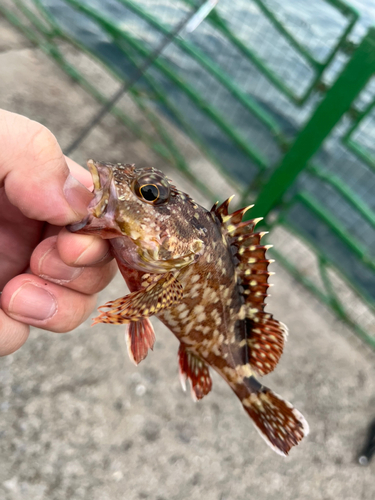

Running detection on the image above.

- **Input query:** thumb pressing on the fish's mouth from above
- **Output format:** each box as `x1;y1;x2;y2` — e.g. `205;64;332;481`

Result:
0;110;92;226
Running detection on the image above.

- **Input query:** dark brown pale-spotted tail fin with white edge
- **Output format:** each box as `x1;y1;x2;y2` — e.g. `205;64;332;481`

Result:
242;384;309;456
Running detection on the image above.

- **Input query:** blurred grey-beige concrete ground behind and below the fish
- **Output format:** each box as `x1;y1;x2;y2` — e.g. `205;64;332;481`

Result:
0;13;375;500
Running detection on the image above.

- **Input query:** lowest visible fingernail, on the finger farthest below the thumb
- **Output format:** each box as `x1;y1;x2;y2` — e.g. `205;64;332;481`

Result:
9;283;57;320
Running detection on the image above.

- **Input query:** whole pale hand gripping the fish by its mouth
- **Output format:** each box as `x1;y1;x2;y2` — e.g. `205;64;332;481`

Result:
0;110;116;356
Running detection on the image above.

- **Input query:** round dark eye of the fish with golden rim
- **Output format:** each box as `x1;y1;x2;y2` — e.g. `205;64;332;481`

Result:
132;171;170;205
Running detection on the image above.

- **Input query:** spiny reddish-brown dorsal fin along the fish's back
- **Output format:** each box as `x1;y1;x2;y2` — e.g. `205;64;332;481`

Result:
212;198;287;375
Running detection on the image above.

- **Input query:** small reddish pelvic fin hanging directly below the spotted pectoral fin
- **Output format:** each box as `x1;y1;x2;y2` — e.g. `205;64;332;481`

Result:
125;318;155;365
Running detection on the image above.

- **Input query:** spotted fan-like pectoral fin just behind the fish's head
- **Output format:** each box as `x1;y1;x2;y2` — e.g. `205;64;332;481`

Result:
93;273;184;325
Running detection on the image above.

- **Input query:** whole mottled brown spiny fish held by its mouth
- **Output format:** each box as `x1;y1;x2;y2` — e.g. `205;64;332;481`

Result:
68;160;309;456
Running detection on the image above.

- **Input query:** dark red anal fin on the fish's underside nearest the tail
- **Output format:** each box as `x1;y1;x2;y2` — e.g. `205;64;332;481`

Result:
178;344;212;401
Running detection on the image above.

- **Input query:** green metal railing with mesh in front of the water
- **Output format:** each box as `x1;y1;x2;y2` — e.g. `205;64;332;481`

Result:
0;0;375;347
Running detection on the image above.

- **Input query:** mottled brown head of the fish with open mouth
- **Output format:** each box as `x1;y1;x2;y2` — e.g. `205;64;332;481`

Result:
68;160;205;273
